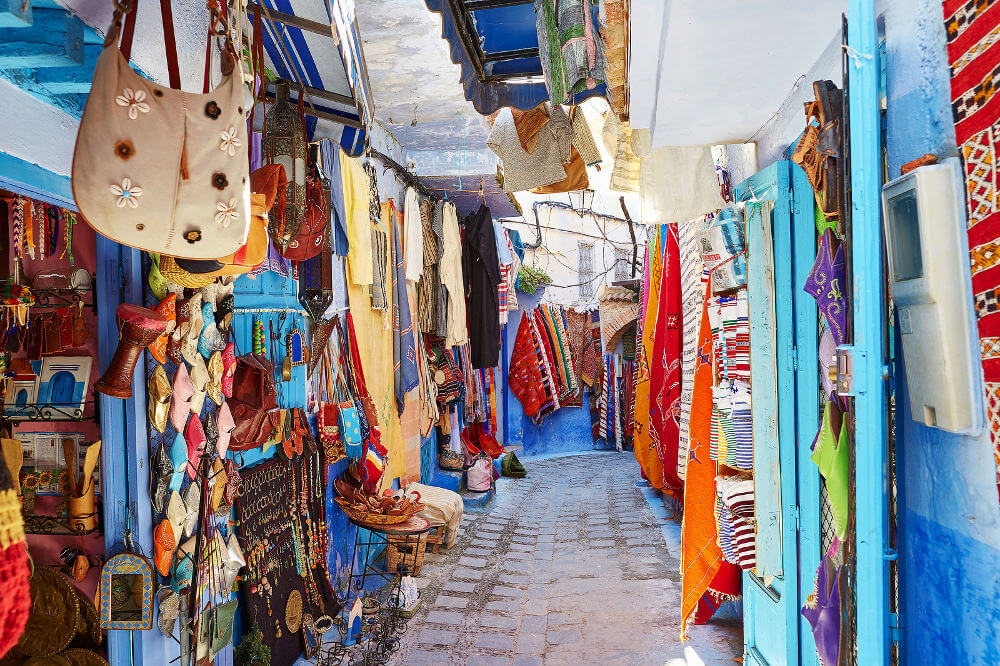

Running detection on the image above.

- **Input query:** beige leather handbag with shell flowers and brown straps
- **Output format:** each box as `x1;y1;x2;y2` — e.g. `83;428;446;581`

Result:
73;0;250;259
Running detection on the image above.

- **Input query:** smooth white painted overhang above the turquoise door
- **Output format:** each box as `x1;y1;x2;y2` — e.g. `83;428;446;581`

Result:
629;0;847;148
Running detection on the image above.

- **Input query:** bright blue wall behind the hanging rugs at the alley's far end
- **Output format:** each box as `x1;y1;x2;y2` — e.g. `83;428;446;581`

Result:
497;292;603;457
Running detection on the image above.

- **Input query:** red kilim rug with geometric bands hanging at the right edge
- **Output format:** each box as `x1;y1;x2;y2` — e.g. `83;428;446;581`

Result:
944;0;1000;492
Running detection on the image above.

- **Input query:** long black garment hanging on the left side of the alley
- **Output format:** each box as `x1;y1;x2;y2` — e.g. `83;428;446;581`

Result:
462;204;500;368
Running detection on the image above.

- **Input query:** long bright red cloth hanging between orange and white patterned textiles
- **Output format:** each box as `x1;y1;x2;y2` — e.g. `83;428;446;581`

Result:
649;224;684;499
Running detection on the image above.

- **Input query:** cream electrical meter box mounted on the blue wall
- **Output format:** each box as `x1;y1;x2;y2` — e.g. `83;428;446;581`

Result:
882;158;983;433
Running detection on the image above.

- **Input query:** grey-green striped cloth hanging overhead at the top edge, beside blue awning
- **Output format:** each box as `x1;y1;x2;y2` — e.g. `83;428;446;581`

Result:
535;0;605;104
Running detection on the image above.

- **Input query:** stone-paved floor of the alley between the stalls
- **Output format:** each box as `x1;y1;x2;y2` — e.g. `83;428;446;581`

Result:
390;452;743;666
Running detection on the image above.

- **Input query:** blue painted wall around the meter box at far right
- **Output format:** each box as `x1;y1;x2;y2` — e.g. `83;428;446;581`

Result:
877;0;1000;664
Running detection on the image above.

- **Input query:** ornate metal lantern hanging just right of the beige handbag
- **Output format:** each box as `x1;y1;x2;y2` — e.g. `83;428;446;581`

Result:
264;81;309;250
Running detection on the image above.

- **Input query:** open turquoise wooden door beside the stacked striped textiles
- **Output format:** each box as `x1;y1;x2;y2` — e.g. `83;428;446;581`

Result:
736;161;820;666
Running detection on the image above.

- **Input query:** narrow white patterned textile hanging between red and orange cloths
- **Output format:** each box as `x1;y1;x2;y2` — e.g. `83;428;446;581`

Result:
677;215;712;481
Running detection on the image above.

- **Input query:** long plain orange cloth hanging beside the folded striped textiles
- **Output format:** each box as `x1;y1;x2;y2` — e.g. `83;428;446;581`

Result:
681;282;722;640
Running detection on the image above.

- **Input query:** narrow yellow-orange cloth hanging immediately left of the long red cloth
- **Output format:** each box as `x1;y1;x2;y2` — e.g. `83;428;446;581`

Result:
632;226;666;490
